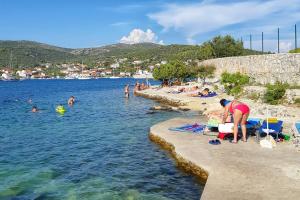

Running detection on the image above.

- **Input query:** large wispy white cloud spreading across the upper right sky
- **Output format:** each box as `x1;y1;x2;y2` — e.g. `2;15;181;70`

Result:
148;0;300;40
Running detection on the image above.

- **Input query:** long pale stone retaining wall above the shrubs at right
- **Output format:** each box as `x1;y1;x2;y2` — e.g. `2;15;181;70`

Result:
200;53;300;85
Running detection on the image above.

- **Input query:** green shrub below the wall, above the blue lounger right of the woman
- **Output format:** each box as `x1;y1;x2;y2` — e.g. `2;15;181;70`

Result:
264;82;288;105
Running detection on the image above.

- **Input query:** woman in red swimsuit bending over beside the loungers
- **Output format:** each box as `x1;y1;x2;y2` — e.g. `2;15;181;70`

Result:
220;99;250;143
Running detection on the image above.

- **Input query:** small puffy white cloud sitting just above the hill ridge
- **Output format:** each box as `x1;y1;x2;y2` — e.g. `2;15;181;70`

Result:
120;29;163;44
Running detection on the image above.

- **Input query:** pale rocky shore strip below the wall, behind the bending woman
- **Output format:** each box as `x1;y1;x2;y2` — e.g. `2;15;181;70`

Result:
136;88;300;134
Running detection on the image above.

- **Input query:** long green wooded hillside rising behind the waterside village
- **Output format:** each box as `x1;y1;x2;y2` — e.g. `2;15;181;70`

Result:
0;36;261;67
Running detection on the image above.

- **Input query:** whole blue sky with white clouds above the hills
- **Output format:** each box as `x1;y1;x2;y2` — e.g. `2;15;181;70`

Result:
0;0;300;52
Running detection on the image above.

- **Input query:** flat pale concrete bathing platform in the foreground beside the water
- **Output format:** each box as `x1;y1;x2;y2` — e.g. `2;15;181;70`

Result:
150;118;300;200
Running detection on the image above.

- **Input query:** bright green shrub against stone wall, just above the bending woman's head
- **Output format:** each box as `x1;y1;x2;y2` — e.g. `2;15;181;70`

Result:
221;72;250;96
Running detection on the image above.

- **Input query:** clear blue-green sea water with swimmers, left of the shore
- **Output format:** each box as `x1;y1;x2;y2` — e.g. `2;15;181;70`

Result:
0;79;203;199
